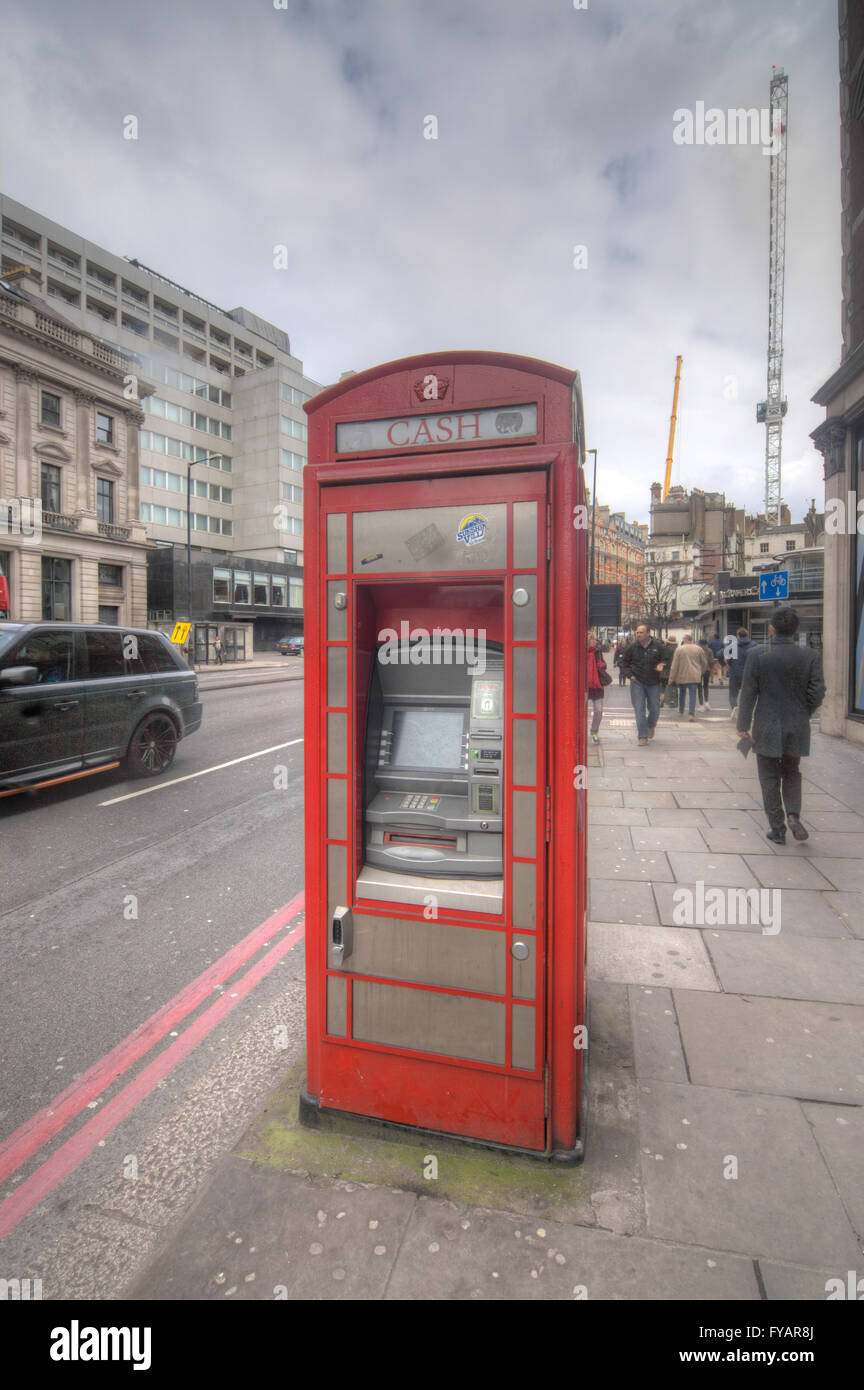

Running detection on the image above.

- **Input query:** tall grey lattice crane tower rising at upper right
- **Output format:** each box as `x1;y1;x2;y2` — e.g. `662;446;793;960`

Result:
756;68;789;525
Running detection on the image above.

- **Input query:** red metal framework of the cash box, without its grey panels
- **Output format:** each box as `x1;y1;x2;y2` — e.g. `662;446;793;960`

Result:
304;353;588;1155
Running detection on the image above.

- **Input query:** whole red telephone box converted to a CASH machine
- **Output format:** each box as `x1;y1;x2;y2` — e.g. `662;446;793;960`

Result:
301;352;588;1159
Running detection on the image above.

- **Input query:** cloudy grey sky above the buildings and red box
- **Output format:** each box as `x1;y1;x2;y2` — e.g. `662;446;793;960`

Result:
0;0;840;520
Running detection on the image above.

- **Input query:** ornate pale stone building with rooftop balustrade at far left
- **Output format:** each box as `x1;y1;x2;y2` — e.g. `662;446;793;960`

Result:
0;270;153;627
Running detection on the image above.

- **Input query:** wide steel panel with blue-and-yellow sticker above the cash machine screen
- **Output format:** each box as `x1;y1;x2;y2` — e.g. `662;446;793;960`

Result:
353;502;507;574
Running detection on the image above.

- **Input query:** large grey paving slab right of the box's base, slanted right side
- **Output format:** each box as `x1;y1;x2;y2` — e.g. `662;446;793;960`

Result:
638;1081;861;1269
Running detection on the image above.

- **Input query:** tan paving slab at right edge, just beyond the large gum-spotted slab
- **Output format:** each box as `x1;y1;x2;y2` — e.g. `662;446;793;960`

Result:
675;990;864;1100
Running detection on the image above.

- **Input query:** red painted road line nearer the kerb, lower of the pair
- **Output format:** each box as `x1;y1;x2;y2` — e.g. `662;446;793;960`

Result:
0;917;306;1240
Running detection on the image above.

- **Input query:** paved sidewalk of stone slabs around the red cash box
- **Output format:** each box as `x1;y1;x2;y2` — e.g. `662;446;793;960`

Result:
125;685;864;1301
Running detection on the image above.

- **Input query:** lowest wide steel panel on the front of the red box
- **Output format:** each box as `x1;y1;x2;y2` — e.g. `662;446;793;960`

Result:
351;980;507;1065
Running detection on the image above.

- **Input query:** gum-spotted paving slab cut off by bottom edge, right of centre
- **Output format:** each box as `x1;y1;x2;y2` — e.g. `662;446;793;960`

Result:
386;1197;760;1302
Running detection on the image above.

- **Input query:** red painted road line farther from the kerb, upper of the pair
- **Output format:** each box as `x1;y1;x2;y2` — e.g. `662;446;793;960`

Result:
0;892;306;1183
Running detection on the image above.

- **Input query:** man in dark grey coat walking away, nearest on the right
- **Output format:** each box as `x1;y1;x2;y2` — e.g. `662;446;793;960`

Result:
738;607;825;845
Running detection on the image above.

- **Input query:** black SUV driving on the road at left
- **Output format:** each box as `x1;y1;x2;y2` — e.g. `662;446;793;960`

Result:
0;623;201;791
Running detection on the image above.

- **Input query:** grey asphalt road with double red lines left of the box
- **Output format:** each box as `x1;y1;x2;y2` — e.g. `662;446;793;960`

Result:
0;669;309;1298
